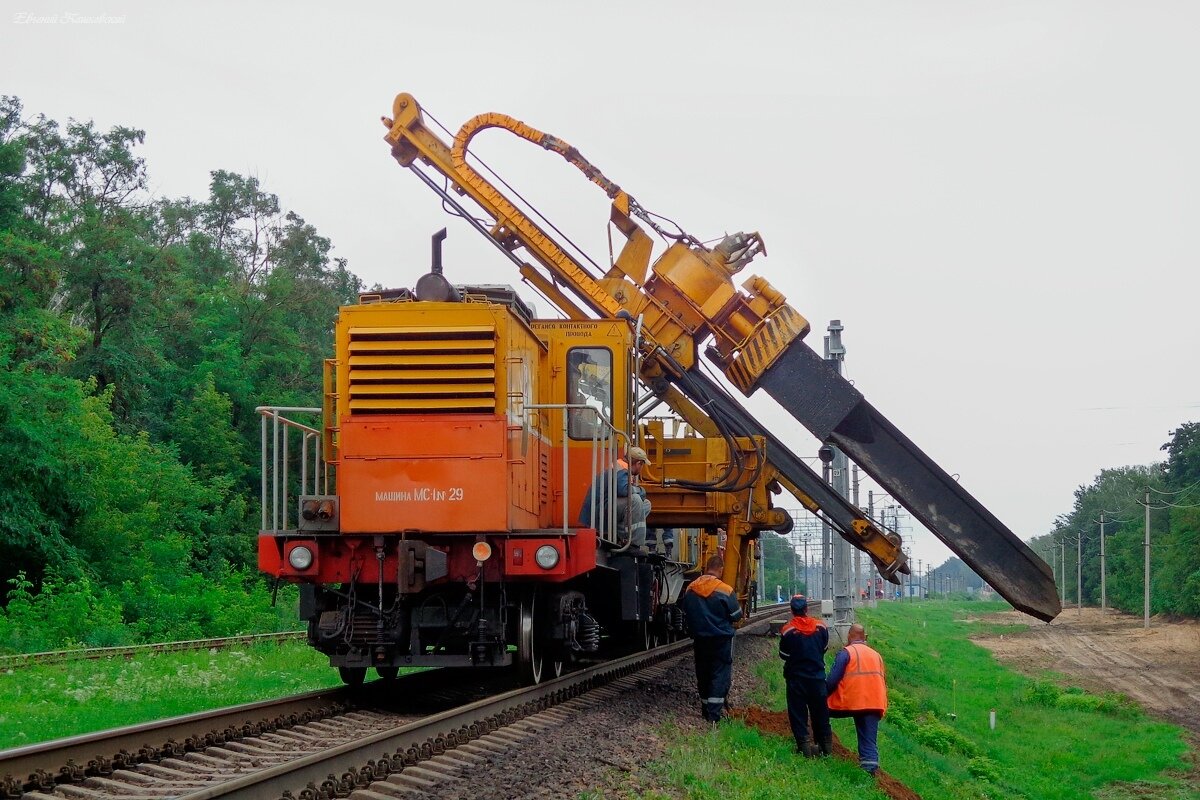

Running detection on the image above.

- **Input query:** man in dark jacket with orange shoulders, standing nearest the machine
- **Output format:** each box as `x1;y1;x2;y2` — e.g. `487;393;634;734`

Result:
682;555;742;722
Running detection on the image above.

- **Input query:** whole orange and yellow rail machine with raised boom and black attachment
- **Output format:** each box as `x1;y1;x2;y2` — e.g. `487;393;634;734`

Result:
258;94;1061;682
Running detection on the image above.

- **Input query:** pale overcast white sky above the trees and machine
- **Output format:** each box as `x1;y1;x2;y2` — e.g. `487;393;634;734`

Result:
0;0;1200;575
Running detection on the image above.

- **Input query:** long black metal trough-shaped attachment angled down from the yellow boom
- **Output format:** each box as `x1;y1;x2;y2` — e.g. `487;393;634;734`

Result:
757;341;1062;621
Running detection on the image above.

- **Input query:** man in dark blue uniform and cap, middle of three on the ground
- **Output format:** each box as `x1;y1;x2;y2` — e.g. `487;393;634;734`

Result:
779;595;833;758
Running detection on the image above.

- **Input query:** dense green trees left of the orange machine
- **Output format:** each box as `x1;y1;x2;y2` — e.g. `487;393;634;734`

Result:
0;97;360;648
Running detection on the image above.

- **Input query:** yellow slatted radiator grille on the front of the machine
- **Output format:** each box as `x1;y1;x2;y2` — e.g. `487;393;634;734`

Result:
348;325;496;414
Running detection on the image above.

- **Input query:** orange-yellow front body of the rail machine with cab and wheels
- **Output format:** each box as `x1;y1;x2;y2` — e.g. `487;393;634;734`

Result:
258;287;662;680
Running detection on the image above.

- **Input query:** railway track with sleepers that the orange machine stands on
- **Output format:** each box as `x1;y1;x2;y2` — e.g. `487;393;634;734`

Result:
0;607;779;800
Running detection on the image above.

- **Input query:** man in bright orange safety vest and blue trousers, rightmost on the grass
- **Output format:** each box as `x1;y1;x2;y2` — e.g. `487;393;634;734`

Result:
826;622;888;775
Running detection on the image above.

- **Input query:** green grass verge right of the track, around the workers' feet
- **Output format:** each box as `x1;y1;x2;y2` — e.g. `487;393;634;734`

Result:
643;601;1200;800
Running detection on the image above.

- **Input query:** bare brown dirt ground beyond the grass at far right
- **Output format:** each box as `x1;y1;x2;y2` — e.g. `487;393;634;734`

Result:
971;608;1200;736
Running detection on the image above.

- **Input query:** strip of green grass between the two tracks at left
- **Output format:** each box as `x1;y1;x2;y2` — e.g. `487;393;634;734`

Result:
0;642;341;750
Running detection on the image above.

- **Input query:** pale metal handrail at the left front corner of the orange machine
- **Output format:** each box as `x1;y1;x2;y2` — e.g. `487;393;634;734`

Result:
254;405;329;531
